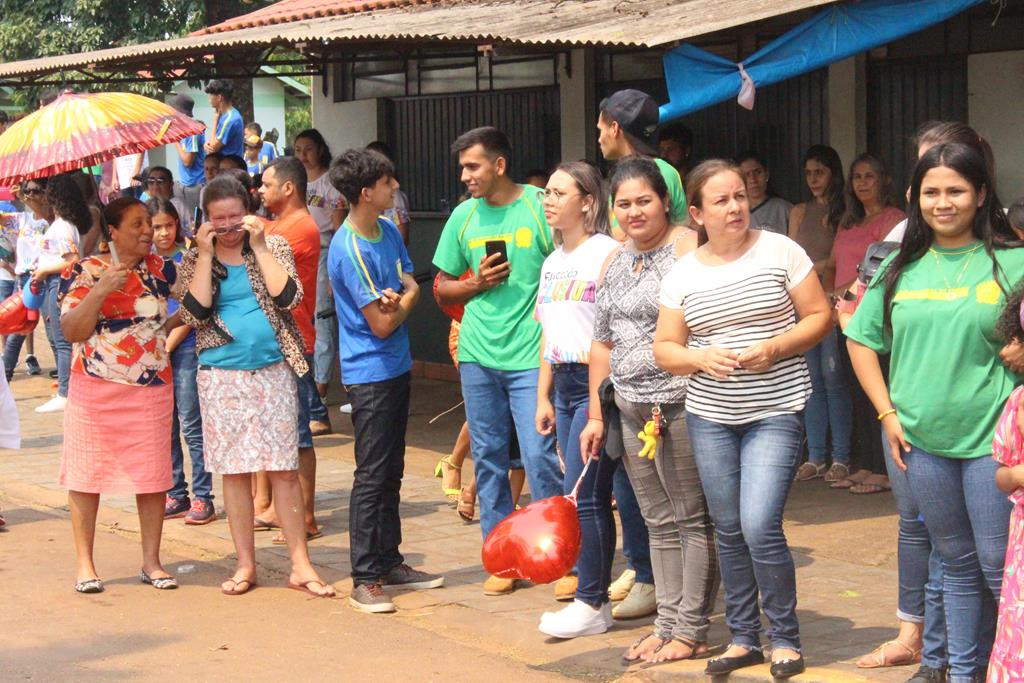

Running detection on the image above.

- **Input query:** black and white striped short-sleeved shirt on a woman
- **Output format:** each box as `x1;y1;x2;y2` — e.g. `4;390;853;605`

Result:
659;230;813;424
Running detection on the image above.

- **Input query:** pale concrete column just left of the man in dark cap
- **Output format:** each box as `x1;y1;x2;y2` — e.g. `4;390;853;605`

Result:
558;47;597;160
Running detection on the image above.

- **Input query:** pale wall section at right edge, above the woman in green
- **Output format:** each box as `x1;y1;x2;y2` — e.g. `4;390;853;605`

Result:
967;50;1024;205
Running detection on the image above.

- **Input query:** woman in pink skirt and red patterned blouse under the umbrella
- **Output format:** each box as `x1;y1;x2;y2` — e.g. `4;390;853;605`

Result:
60;198;177;593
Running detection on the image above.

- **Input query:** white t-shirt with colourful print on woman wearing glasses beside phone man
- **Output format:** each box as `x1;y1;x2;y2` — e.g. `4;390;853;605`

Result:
537;233;620;364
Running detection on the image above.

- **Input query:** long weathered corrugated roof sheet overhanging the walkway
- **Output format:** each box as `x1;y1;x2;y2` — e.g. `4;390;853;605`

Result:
0;0;831;78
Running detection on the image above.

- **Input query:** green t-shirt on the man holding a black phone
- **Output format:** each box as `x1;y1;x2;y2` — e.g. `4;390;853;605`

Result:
434;185;554;371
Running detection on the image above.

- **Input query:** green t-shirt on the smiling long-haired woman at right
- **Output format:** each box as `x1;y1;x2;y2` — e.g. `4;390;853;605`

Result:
846;243;1024;459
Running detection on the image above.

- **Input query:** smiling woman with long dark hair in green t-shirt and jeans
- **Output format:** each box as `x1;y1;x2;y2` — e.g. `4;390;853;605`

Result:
846;144;1024;682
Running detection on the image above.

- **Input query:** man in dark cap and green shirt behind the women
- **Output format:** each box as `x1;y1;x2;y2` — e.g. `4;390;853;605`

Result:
597;90;687;242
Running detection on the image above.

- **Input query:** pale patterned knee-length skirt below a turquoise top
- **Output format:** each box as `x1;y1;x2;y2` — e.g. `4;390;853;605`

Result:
197;360;299;474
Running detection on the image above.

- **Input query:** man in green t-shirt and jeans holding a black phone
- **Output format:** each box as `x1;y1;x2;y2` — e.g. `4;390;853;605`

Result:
433;126;562;595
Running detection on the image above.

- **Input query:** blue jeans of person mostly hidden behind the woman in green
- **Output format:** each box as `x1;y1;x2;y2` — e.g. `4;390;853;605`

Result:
882;429;947;669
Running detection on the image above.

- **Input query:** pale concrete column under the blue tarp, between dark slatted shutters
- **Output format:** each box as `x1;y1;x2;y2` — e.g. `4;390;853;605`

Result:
828;54;867;166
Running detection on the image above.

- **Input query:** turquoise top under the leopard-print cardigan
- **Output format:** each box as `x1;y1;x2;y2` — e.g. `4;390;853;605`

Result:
199;264;284;370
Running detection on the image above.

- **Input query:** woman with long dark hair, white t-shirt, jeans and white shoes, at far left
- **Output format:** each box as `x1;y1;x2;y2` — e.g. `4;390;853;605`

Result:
32;173;92;413
